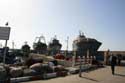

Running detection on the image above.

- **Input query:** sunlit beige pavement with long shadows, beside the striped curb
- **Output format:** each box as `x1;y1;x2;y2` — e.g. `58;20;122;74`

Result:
22;66;125;83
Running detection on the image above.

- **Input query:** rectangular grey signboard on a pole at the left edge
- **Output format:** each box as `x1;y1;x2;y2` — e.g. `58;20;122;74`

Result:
0;26;10;40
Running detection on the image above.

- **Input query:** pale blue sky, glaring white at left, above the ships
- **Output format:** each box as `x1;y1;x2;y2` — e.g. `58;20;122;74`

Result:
0;0;125;51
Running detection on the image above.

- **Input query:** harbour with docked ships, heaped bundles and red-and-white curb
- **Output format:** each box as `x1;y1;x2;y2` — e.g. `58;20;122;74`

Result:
0;28;124;83
